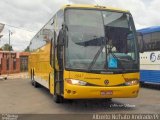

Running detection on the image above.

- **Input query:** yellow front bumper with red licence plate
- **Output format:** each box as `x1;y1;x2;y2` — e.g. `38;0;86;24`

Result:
63;84;139;99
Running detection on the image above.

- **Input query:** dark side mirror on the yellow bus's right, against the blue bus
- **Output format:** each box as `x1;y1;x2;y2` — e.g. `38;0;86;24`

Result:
136;32;144;53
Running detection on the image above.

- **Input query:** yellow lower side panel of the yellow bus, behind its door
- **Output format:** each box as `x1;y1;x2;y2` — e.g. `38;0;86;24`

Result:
29;44;52;89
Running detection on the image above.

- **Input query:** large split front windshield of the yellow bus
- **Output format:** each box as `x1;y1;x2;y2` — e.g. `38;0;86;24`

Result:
65;9;138;71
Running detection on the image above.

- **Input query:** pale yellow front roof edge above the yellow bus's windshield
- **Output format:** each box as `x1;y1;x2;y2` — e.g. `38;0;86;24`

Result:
62;4;129;12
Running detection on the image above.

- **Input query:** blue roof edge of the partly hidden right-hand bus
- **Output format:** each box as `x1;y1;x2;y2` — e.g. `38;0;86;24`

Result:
137;26;160;34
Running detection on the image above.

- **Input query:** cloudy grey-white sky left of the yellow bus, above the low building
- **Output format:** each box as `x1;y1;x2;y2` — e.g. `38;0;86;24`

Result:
0;0;68;50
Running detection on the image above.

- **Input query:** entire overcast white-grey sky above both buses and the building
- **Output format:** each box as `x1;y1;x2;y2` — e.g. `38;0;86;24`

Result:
0;0;160;51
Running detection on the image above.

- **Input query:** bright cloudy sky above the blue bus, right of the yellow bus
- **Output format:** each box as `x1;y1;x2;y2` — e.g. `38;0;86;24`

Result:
97;0;160;29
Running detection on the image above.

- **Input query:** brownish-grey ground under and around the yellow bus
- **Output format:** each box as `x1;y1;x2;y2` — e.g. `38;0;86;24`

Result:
0;75;160;114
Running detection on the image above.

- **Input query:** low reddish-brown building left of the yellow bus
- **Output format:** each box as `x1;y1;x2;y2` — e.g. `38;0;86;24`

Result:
0;51;29;74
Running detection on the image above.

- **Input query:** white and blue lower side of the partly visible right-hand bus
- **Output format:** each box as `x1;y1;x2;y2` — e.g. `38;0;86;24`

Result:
140;51;160;83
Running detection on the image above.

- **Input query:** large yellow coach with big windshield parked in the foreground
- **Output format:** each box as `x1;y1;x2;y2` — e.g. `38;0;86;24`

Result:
29;5;139;103
